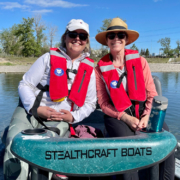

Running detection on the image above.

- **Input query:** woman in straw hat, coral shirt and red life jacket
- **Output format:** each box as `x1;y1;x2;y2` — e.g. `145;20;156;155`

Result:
95;18;174;180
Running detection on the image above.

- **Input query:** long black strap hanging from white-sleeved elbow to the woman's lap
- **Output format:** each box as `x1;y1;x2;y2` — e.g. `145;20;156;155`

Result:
31;83;60;135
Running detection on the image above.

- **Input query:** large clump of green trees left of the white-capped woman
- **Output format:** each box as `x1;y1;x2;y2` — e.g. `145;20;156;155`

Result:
0;15;58;57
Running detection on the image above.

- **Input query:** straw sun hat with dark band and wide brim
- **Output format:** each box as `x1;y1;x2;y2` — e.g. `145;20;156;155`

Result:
96;18;139;46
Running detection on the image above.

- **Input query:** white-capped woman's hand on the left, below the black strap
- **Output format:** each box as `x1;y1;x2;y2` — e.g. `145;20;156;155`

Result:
37;106;61;121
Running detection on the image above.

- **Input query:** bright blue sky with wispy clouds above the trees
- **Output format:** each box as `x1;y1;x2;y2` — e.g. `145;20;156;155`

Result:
0;0;180;53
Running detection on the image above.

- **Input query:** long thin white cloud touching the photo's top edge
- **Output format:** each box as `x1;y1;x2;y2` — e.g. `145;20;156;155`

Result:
24;0;88;8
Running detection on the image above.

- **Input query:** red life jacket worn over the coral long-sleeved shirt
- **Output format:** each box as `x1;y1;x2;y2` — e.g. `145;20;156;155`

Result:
98;49;146;118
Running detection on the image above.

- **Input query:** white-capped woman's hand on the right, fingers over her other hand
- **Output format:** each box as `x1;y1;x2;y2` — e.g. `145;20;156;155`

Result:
51;109;74;123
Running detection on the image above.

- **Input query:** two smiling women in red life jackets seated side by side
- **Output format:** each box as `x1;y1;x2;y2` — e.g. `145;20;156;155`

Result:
4;18;174;180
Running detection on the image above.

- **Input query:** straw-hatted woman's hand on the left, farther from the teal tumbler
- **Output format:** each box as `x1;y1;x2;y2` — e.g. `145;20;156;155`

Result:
121;113;140;131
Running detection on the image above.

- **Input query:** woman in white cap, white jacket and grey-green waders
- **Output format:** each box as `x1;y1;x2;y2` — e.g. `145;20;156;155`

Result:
4;19;96;180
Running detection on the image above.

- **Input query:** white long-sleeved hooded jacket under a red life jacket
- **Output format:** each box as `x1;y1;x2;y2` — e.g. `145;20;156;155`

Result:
18;47;97;123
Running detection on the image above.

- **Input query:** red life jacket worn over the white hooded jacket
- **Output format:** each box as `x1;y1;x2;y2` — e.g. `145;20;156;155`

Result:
49;48;94;107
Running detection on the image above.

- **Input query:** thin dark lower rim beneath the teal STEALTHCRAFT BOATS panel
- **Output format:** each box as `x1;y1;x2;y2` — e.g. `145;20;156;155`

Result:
11;145;177;177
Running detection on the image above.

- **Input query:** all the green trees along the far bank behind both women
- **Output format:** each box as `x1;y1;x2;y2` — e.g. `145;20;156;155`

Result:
0;15;180;59
